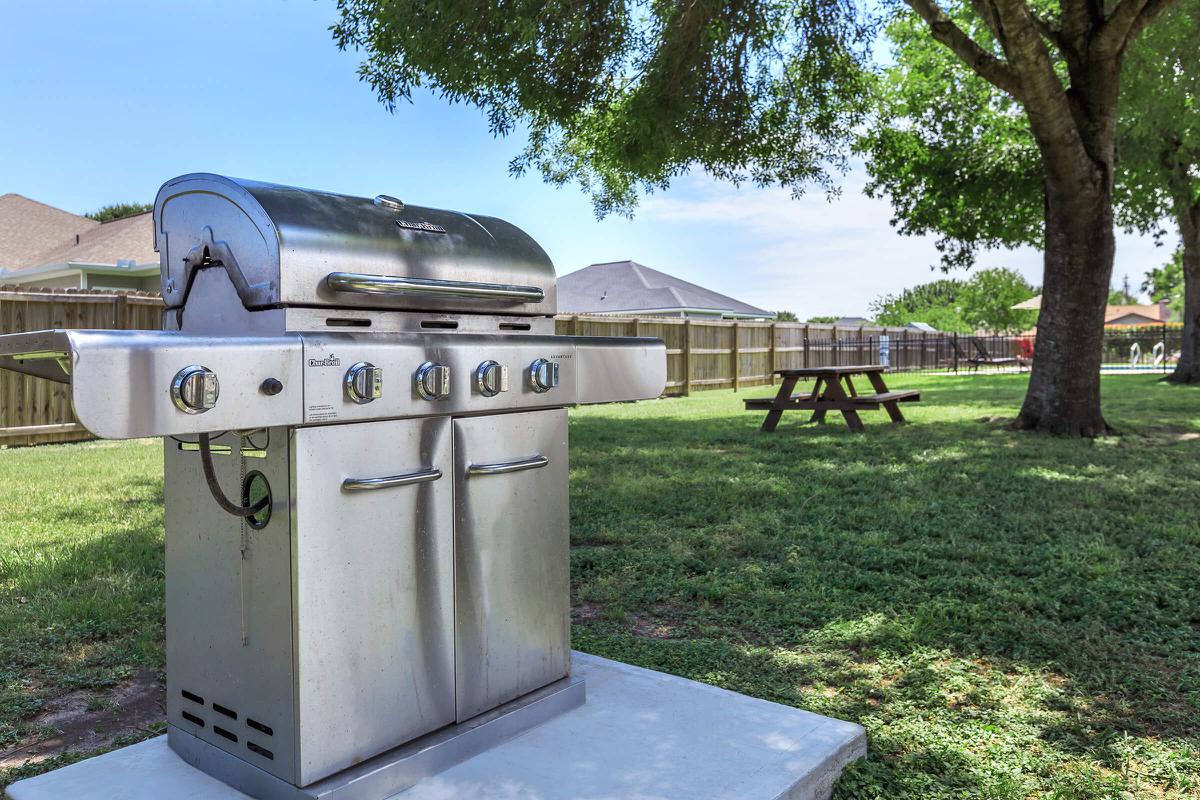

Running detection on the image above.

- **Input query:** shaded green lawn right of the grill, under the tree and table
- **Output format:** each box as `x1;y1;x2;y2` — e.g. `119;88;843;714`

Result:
571;407;1200;796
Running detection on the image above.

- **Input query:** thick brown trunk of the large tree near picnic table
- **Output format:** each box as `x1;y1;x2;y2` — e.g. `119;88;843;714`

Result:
1014;163;1116;437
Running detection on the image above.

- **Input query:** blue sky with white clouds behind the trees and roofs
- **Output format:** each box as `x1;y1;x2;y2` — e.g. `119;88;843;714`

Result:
0;0;1166;318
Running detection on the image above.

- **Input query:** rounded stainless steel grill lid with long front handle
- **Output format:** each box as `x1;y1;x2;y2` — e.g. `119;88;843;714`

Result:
154;173;557;317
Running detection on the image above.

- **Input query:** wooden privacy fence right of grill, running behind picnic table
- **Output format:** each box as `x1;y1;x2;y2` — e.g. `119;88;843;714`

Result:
556;314;916;395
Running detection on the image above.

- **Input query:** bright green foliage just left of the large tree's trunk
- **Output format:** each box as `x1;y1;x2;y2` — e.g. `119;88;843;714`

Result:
856;7;1045;269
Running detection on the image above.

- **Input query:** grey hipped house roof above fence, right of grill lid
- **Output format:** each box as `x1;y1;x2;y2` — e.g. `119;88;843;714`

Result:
558;261;775;319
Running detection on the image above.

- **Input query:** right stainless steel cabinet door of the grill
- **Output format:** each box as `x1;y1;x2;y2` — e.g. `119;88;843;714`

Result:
454;409;570;722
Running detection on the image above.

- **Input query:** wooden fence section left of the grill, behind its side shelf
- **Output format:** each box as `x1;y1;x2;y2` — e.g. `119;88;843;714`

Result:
0;287;162;445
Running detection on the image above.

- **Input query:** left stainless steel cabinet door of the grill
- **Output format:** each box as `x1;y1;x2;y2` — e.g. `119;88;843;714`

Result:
293;417;454;786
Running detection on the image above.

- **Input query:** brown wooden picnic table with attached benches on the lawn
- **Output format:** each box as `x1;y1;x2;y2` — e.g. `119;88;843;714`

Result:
745;363;920;432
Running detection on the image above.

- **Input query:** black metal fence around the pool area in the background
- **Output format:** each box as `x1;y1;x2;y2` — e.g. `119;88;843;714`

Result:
806;324;1183;373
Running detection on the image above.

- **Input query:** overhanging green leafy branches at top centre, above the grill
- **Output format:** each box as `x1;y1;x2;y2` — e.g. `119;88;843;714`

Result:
332;0;871;215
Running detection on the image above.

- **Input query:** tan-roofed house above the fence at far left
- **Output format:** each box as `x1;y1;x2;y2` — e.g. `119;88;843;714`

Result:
0;194;160;291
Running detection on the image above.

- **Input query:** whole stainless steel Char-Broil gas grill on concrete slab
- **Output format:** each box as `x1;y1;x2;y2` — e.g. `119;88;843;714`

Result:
0;174;666;800
